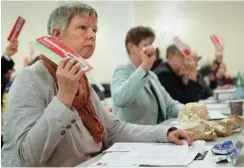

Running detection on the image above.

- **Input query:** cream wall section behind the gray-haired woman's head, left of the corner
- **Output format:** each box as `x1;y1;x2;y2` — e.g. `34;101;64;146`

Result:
1;1;133;82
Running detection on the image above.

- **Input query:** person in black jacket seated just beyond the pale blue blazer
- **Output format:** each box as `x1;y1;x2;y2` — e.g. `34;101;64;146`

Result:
154;45;212;104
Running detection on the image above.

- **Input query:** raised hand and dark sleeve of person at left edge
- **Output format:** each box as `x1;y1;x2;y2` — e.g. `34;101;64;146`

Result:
1;40;18;105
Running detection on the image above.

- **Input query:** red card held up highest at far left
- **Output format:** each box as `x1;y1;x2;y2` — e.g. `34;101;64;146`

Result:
8;16;25;42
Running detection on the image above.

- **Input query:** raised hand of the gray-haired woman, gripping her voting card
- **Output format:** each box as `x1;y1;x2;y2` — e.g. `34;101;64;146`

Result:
56;58;84;108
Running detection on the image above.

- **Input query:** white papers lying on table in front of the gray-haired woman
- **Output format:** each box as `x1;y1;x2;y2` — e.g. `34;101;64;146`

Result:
90;142;205;167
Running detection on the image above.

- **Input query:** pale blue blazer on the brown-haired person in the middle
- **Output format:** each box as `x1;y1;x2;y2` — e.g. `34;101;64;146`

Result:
111;61;184;125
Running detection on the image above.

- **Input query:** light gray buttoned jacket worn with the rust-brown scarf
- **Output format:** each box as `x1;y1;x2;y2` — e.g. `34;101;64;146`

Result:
2;61;173;167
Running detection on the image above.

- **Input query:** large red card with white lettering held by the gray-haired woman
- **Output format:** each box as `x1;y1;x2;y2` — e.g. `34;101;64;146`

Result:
36;36;93;72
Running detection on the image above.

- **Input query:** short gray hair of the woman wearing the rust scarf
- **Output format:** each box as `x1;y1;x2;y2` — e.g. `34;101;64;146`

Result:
47;2;97;35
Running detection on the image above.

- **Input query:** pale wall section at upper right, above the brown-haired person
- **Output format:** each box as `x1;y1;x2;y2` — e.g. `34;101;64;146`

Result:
134;1;244;74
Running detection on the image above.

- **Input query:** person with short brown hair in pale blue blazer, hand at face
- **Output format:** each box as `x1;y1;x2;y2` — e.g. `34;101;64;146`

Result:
111;26;183;125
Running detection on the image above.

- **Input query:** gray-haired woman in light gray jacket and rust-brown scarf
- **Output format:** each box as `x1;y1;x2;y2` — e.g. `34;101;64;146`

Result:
2;3;192;167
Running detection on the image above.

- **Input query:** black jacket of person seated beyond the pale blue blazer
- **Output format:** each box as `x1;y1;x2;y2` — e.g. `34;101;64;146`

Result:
154;63;213;104
